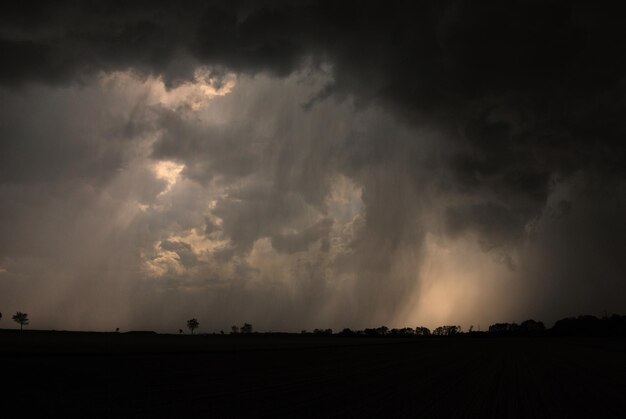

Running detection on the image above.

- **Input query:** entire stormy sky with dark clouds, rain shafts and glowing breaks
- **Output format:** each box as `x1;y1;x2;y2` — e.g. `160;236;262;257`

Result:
0;1;626;332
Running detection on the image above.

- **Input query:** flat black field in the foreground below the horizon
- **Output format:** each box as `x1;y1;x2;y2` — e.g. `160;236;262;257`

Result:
0;331;626;418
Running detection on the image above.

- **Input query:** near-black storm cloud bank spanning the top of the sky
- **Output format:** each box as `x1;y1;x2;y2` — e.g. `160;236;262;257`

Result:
0;1;626;185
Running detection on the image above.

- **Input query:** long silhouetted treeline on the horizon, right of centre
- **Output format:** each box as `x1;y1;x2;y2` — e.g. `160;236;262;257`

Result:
292;314;626;337
